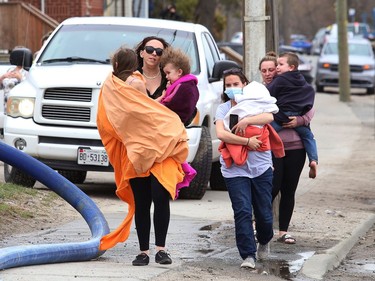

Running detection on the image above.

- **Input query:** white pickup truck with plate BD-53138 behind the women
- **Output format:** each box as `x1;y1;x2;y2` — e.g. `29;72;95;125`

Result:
3;17;237;199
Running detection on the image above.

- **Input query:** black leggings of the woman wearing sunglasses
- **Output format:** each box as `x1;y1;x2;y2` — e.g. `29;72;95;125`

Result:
130;174;170;251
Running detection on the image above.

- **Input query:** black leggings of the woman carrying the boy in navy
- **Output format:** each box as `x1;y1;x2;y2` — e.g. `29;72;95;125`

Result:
272;149;306;232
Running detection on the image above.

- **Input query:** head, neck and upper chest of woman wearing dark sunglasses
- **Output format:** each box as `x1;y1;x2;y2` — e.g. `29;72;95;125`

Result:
135;36;169;99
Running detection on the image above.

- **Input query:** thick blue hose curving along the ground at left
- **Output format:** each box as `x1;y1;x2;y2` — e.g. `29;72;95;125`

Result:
0;141;109;270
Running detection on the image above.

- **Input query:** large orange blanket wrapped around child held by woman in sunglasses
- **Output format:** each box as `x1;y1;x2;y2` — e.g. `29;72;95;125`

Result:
97;73;188;250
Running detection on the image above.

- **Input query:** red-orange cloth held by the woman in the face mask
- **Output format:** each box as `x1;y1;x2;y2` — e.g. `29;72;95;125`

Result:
219;124;285;167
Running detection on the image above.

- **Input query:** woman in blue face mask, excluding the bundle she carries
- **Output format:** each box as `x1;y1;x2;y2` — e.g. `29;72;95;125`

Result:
215;68;280;270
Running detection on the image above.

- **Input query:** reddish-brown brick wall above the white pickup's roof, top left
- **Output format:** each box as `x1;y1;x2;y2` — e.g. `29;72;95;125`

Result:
9;0;104;22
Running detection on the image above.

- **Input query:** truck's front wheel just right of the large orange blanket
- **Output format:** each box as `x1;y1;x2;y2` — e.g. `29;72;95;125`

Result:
178;127;212;199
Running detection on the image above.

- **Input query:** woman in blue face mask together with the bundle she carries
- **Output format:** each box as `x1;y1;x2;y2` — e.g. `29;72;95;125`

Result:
215;68;283;270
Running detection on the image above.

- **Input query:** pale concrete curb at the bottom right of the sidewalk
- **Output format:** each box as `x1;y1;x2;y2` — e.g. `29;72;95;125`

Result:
301;214;375;280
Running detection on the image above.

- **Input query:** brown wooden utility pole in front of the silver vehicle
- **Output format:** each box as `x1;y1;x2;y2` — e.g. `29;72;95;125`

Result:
336;0;350;102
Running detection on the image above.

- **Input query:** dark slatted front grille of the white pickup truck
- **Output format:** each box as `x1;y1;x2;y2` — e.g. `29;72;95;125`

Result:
42;88;92;122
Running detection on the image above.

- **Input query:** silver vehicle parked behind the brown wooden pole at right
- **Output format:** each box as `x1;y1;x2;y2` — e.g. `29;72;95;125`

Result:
315;38;375;94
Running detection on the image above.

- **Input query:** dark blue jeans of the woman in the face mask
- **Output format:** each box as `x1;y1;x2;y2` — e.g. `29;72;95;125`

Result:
224;168;273;259
